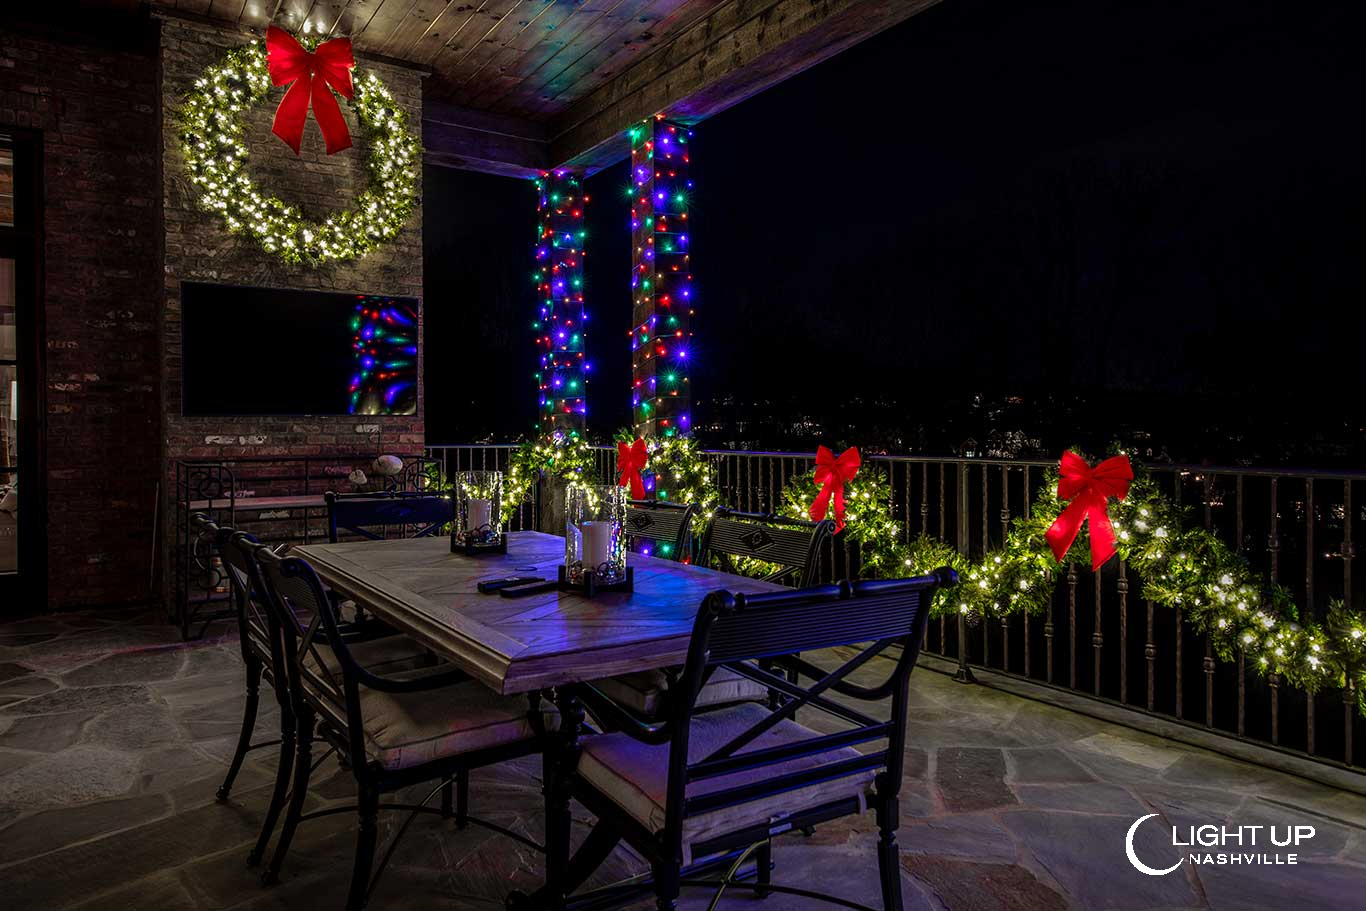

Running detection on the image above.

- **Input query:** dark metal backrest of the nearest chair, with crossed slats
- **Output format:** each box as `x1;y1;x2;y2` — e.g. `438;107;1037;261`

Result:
655;570;958;839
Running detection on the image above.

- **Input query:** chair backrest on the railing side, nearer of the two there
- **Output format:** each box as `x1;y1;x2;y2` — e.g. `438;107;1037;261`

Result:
702;509;835;586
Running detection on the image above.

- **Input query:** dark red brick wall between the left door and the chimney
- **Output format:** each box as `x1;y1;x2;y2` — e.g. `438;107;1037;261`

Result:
0;20;161;612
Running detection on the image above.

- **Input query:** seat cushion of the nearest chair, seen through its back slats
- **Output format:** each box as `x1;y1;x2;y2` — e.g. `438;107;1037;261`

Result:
578;702;876;863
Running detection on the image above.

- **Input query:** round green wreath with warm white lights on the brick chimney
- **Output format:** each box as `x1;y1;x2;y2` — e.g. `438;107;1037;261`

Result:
178;37;422;265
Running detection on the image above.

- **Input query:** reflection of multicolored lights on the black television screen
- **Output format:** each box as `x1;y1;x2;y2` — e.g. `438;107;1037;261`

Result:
348;295;418;414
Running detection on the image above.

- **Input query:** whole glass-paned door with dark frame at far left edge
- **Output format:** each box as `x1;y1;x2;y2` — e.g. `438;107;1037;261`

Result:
0;132;46;606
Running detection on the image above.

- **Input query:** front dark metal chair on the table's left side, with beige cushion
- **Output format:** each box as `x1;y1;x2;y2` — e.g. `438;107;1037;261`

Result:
257;549;559;911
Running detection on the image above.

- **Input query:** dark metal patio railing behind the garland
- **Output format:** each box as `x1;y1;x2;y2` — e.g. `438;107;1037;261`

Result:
429;447;1366;768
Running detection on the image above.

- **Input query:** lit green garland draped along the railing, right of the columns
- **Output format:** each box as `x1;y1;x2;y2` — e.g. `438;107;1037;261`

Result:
783;453;1366;714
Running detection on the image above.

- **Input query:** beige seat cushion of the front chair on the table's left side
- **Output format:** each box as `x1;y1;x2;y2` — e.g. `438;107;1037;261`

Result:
361;682;560;769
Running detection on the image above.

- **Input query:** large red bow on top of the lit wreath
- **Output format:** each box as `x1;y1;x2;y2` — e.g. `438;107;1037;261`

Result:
265;26;355;154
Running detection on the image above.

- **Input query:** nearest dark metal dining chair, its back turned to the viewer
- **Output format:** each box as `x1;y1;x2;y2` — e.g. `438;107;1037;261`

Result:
538;568;956;911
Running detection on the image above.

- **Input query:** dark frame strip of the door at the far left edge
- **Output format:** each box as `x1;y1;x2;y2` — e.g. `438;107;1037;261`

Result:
0;127;48;611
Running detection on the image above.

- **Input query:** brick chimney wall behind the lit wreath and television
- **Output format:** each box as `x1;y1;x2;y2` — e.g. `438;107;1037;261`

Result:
161;19;423;600
